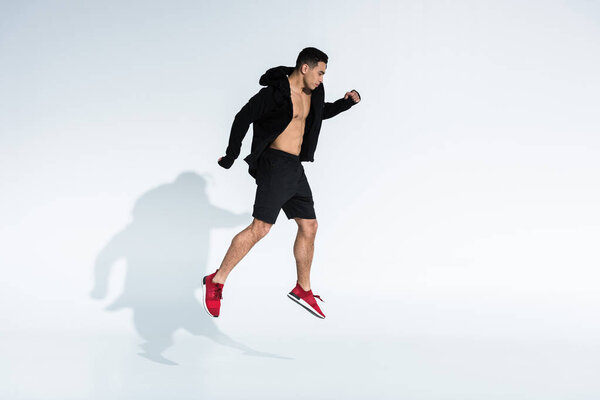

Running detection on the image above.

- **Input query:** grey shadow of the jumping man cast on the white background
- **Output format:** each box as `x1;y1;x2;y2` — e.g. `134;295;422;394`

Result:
91;172;287;365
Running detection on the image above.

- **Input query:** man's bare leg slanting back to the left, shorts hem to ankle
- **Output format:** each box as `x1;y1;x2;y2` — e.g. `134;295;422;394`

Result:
213;218;273;283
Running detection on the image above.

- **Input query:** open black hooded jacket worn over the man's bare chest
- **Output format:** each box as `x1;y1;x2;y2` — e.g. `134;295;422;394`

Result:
219;66;360;178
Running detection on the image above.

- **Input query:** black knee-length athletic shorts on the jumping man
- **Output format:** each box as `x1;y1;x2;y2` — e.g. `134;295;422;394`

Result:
252;147;317;224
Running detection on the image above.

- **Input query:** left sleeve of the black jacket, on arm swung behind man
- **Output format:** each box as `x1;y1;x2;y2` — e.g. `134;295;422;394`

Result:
219;87;269;169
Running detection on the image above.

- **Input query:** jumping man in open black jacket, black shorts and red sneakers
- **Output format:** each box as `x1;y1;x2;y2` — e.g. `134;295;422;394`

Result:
202;47;360;318
